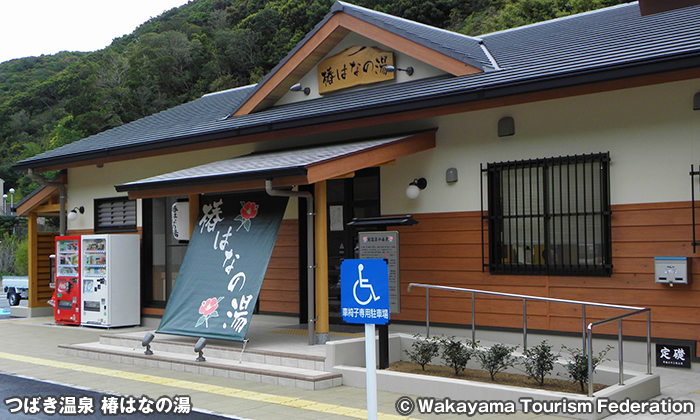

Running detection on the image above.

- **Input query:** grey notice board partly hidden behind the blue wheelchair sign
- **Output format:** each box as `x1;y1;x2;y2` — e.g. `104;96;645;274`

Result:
359;231;401;314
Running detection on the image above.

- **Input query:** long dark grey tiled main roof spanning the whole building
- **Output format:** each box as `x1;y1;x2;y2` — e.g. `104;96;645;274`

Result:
12;3;700;168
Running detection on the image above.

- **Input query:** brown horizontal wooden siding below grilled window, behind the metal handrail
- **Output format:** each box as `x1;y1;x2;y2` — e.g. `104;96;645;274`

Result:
394;202;700;341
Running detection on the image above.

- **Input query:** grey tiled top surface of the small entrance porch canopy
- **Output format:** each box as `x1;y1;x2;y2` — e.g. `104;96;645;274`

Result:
117;136;406;191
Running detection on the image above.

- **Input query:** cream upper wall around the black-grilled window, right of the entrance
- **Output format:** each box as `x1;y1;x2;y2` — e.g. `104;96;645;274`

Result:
381;80;700;215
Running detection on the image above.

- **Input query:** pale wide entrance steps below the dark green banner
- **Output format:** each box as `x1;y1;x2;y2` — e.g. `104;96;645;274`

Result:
58;334;343;390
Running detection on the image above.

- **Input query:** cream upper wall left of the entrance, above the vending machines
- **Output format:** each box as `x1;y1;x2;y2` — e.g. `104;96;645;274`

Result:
66;144;297;230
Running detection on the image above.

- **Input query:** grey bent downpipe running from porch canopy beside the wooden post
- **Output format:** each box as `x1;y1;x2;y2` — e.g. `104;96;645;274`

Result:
265;179;316;346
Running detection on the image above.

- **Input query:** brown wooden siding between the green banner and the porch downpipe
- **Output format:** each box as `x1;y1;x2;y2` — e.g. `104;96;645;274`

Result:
259;220;299;314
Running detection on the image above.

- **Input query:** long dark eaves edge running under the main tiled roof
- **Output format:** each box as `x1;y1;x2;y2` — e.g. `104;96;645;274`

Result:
12;51;700;171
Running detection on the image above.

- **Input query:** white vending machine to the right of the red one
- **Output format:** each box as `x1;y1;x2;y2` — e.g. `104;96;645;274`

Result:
80;234;141;328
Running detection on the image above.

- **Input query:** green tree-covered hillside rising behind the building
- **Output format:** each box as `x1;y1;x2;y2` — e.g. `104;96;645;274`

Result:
0;0;625;200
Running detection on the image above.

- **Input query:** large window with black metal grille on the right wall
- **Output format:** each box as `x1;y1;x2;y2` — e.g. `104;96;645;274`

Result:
484;153;612;276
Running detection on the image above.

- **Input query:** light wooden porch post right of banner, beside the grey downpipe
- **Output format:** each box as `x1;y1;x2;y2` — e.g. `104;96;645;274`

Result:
314;181;329;344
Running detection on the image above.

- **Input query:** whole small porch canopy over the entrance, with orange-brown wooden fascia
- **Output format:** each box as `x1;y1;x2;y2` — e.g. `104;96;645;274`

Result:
115;130;436;198
